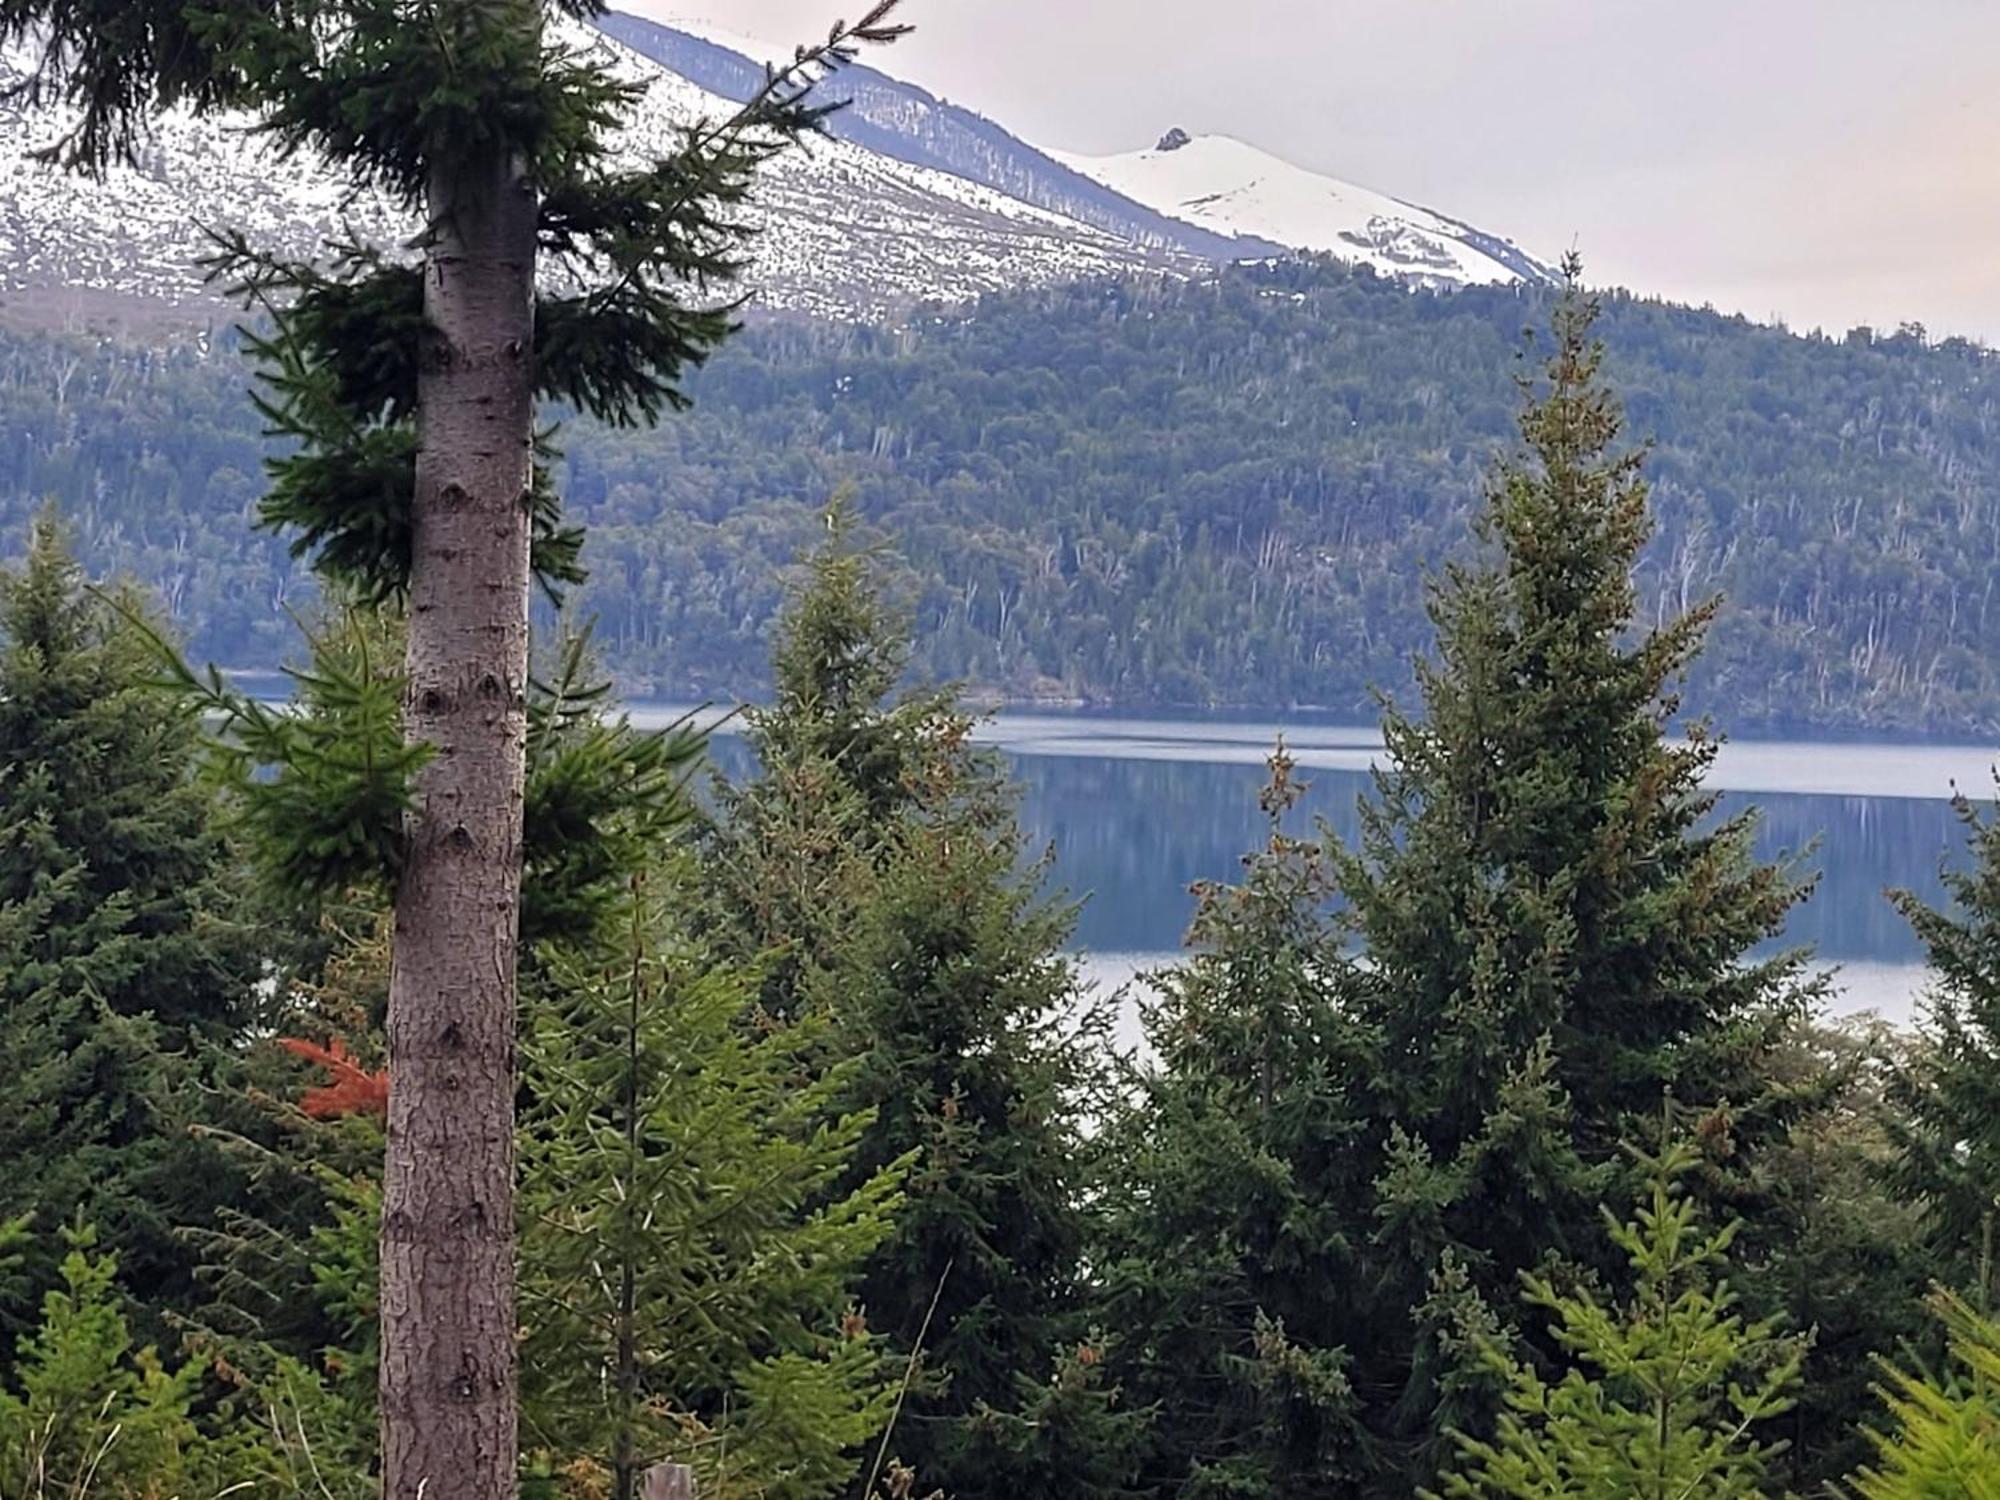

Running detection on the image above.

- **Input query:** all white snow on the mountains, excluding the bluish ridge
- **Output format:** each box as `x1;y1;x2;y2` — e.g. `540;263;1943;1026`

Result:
0;25;1534;318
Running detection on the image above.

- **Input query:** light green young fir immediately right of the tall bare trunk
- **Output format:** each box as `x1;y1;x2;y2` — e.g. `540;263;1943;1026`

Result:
522;870;908;1500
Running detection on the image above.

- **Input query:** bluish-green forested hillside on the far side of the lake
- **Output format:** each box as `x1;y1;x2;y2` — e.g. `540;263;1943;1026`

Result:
0;264;2000;732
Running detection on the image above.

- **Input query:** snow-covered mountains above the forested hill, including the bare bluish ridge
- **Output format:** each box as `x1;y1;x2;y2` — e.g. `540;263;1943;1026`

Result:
0;12;1546;318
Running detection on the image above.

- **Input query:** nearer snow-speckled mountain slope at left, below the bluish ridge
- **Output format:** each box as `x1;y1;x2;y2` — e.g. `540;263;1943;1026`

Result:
0;20;1198;328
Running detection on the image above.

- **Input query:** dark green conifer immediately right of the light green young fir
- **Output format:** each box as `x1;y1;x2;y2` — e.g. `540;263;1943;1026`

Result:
828;810;1100;1472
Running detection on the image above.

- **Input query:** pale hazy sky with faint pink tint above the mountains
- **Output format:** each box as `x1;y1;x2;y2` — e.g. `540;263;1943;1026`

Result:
614;0;2000;342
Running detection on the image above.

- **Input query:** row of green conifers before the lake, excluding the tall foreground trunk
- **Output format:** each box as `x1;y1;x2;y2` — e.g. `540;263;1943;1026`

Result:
0;284;2000;1500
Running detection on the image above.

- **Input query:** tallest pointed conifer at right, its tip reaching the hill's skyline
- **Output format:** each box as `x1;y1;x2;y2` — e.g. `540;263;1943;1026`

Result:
1336;260;1810;1472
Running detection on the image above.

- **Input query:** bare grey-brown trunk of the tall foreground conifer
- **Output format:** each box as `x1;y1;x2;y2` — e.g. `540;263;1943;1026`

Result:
382;111;536;1500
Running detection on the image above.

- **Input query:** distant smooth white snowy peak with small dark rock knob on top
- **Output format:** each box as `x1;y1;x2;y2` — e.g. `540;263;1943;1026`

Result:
1050;130;1554;286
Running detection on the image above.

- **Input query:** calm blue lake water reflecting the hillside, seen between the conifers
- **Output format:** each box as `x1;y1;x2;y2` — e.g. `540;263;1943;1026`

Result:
644;710;2000;1020
